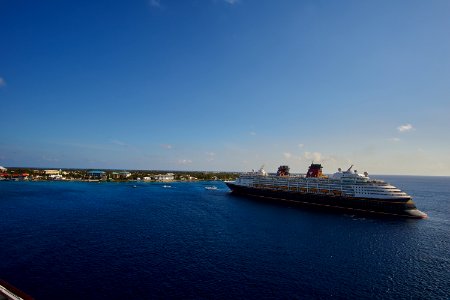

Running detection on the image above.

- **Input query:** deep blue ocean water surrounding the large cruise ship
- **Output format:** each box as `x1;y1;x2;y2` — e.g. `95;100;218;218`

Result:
0;176;450;299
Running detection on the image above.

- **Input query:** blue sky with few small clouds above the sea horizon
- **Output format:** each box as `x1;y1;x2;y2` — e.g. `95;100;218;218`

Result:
0;0;450;175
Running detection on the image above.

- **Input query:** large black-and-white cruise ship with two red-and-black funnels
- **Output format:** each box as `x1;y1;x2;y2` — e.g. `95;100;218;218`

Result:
225;163;427;219
